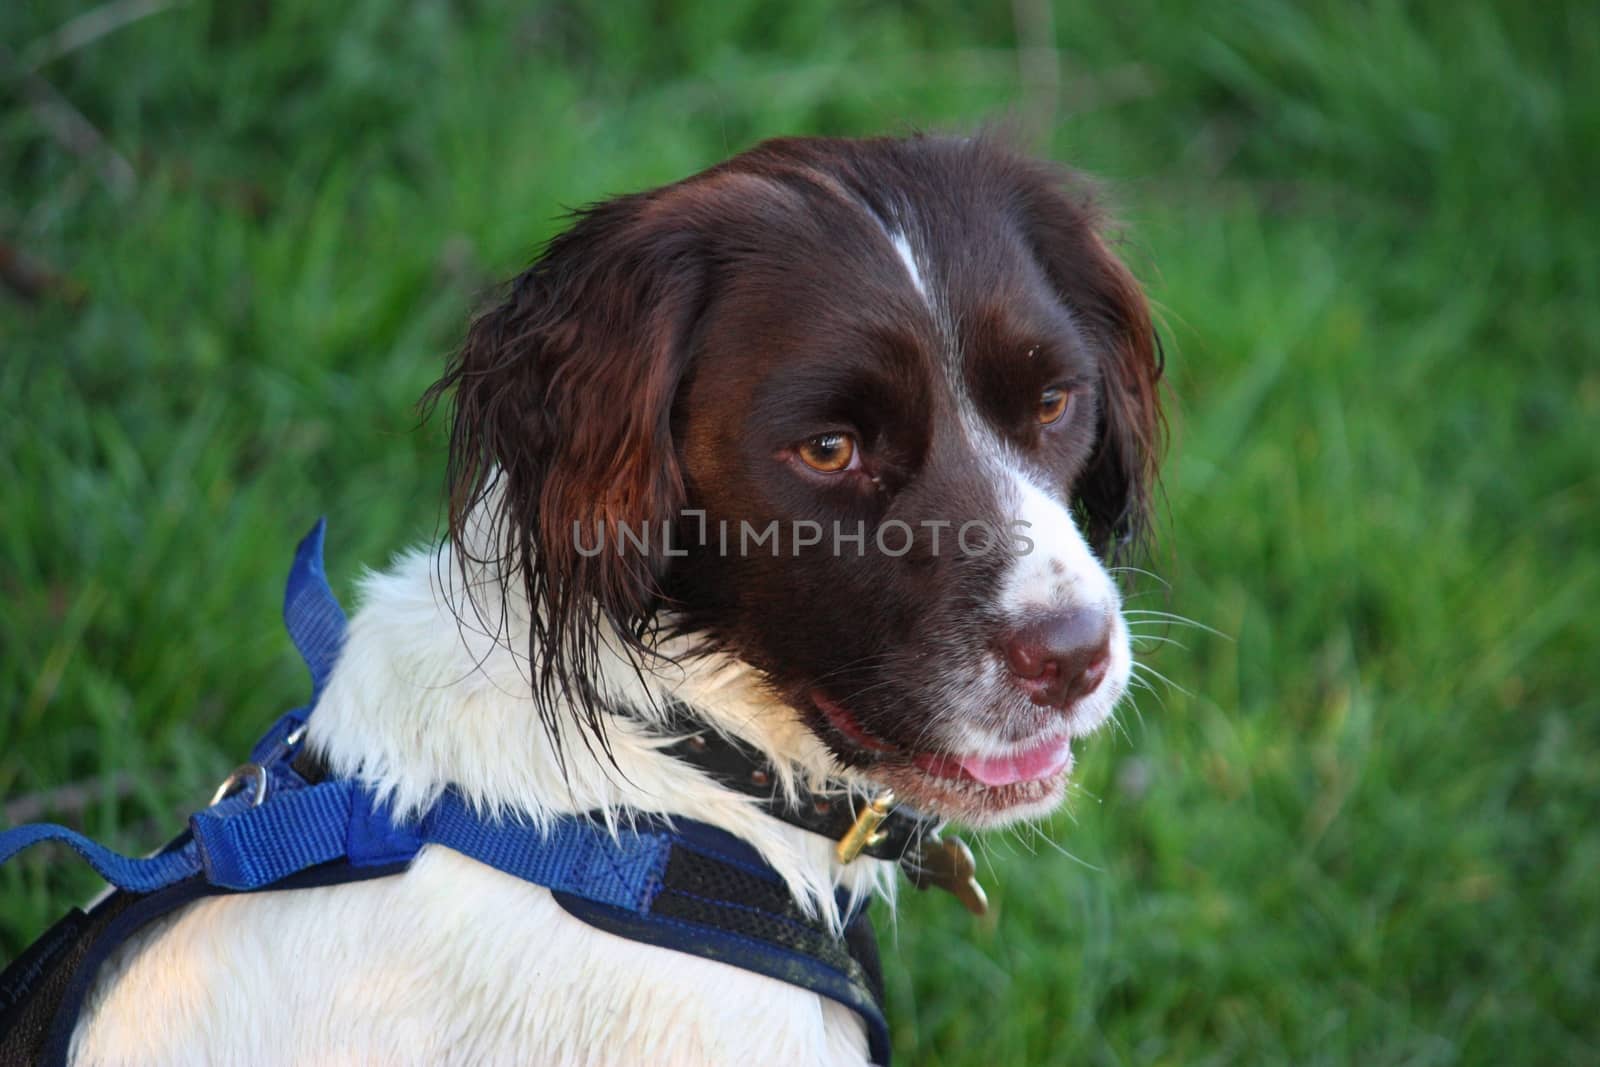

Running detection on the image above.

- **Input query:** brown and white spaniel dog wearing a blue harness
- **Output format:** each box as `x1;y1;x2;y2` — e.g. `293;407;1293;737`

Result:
56;136;1163;1067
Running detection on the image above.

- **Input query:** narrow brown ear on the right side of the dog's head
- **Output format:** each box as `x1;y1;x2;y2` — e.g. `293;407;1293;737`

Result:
1022;166;1166;558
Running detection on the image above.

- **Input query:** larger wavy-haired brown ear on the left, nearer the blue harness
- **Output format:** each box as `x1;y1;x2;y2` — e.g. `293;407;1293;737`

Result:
424;194;706;745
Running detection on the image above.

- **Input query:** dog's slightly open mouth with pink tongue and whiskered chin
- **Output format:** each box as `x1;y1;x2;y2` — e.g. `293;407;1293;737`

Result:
810;691;1072;825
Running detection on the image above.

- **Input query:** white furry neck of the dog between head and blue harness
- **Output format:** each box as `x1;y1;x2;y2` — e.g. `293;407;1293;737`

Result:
309;545;894;923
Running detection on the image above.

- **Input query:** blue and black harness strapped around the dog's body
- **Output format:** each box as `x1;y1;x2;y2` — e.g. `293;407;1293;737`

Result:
0;522;890;1067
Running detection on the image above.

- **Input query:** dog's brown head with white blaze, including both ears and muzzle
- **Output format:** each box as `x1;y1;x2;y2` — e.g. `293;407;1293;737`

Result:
435;138;1162;824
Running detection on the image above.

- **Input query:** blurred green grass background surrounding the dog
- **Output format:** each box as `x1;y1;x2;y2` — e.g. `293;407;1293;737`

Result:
0;0;1600;1065
